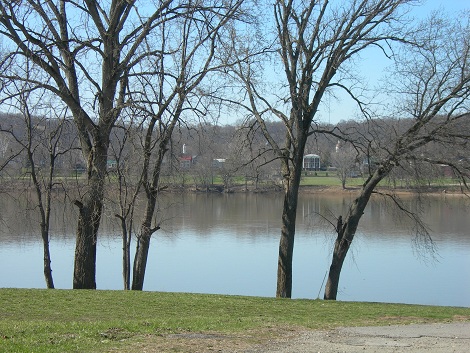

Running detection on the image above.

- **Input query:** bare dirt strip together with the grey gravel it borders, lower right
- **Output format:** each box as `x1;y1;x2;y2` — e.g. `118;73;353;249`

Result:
106;316;470;353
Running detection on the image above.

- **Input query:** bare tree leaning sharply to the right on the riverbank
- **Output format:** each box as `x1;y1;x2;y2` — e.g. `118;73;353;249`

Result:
324;13;470;299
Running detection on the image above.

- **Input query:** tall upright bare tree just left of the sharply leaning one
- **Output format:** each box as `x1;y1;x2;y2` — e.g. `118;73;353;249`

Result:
229;0;414;298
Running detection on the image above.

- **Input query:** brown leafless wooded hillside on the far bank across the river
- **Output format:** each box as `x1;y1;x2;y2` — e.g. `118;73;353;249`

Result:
0;113;468;191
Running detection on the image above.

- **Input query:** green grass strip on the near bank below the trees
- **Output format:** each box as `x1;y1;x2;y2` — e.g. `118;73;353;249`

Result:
0;289;470;353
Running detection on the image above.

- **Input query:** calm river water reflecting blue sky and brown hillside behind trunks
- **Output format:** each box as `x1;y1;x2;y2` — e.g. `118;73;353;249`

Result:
0;190;470;307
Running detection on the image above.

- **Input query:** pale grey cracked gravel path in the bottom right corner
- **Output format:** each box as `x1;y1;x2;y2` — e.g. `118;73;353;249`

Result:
245;321;470;353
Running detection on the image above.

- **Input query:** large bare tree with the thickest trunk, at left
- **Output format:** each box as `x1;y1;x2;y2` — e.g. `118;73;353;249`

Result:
0;0;188;288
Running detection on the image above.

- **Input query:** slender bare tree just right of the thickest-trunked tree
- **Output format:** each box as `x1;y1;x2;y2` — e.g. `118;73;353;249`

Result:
102;0;250;290
